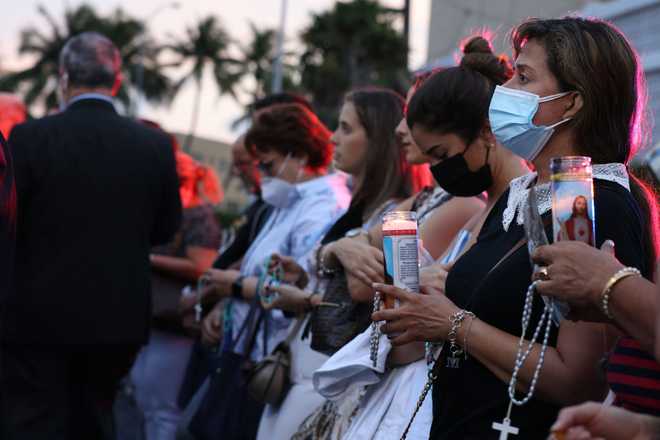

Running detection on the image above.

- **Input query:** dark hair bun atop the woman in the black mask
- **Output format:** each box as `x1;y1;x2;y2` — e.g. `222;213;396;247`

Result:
460;35;513;84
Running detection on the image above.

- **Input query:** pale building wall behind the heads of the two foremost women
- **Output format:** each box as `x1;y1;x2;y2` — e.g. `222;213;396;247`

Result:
425;0;660;150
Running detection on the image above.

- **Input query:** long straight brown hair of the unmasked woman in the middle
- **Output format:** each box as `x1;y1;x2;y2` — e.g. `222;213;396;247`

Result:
344;87;416;219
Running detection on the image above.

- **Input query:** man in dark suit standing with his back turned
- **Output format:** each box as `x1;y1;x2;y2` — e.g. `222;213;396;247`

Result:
0;33;181;440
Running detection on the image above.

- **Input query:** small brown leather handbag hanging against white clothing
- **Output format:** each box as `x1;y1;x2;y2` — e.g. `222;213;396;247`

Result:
245;318;304;406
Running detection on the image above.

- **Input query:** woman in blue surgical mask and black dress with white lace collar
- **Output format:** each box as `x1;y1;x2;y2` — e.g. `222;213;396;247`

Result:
374;17;660;439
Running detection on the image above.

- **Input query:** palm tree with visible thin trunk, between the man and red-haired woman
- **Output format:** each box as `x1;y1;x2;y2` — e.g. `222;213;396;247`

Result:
168;16;243;149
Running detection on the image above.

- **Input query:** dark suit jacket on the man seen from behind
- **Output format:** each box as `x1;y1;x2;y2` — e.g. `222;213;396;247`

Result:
0;99;181;344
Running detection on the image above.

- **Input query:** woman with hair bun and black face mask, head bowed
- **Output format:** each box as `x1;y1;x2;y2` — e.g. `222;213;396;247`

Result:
301;37;528;439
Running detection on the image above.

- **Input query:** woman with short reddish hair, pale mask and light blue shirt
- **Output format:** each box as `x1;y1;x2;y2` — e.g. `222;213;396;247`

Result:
195;104;350;440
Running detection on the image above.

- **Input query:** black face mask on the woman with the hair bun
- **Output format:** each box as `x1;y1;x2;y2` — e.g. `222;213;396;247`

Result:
431;147;493;197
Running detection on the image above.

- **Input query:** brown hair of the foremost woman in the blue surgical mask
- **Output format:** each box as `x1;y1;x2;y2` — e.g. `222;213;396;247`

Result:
511;17;658;276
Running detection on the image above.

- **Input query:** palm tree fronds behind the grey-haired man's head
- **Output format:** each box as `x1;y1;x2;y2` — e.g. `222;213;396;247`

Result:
0;5;172;111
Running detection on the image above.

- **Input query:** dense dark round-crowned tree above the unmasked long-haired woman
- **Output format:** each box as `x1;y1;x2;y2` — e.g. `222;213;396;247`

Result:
300;0;408;126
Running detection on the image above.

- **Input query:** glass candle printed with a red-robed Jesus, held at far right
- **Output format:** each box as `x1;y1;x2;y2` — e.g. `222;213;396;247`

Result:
550;156;596;246
